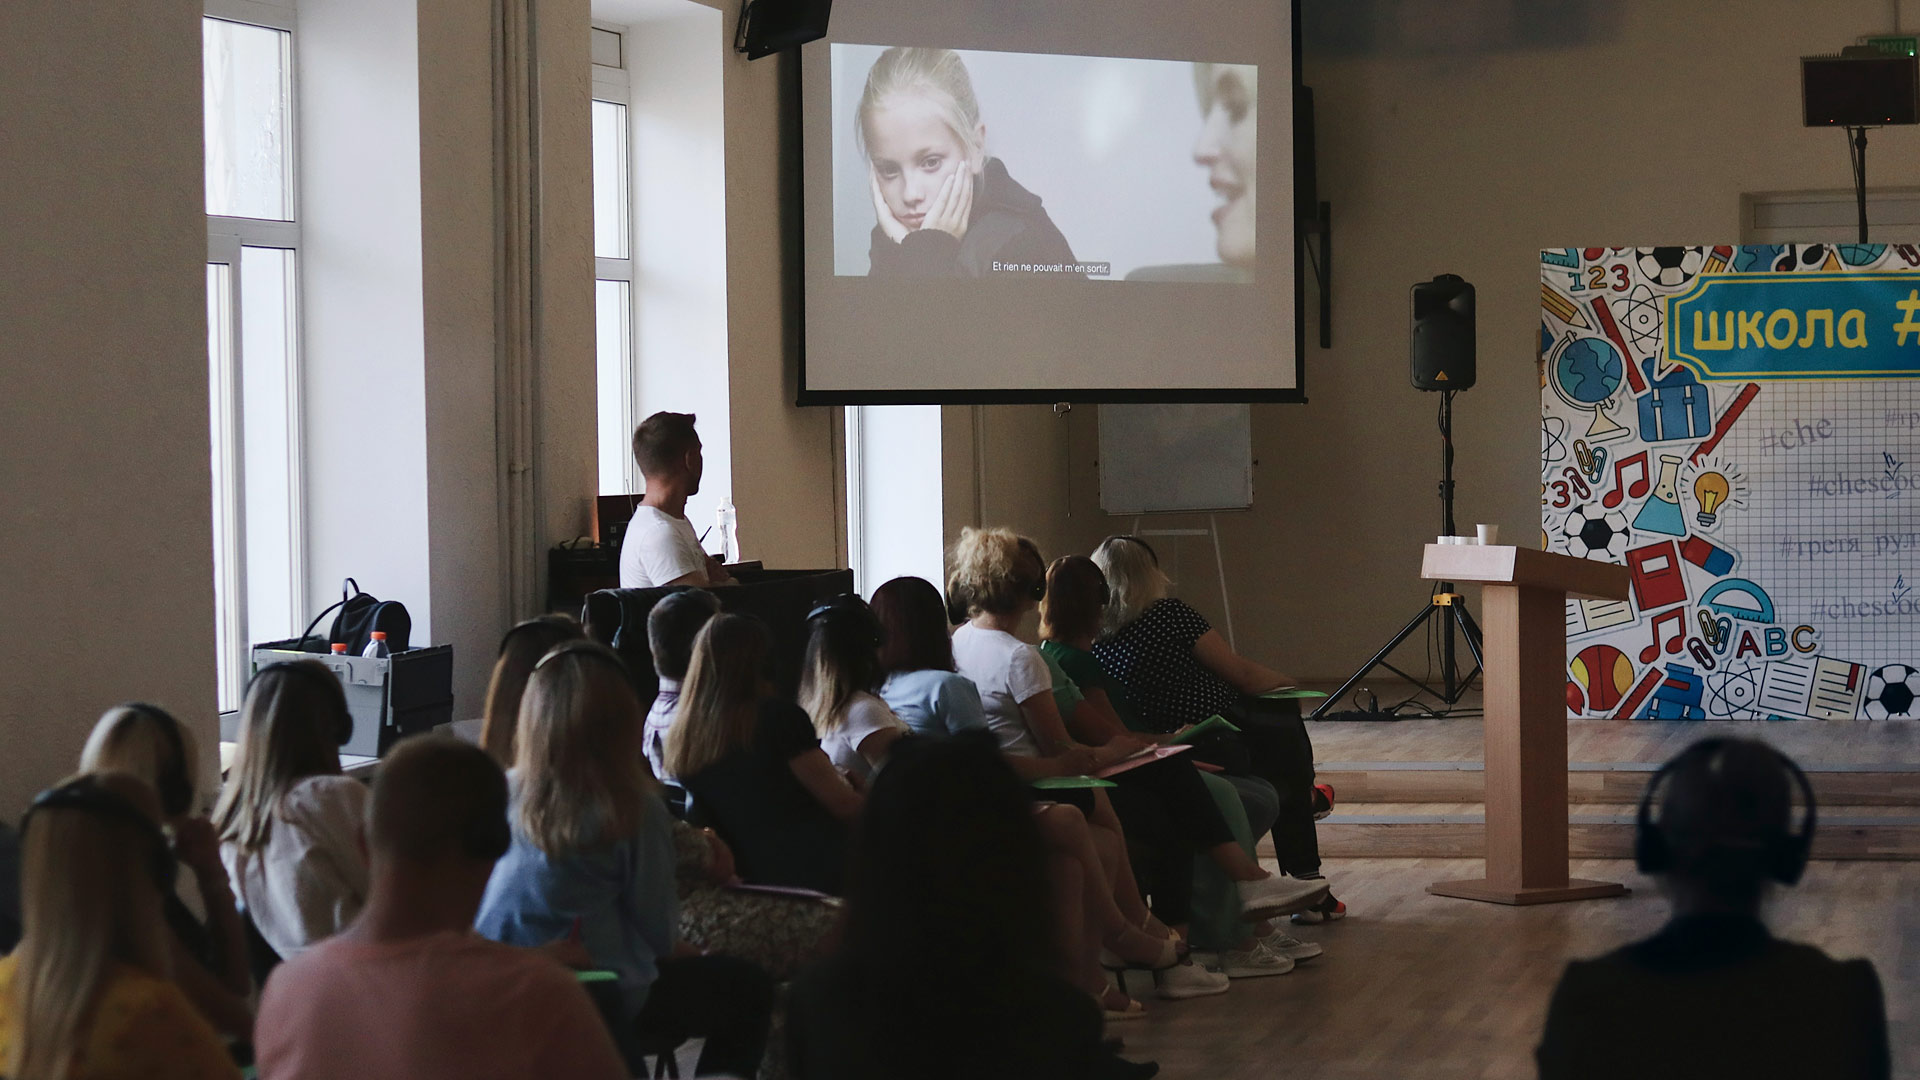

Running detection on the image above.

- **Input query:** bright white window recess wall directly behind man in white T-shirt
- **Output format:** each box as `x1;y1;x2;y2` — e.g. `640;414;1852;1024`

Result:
626;2;729;545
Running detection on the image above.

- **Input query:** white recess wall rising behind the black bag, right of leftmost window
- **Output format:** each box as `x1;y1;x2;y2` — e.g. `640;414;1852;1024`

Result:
294;0;436;644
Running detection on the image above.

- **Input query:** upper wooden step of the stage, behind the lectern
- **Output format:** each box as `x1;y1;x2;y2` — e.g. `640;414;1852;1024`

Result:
1315;761;1920;807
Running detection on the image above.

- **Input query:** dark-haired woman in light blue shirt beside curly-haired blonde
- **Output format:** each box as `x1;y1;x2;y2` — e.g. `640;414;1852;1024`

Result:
874;578;987;734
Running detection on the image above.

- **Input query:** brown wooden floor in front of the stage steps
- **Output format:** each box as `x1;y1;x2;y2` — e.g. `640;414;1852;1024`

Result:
1114;859;1920;1080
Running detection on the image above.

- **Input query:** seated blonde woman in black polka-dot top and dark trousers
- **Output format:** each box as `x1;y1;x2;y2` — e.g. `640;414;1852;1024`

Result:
1092;536;1346;922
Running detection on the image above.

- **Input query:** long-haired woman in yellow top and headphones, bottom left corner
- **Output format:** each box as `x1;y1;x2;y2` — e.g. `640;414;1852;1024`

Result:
0;773;240;1080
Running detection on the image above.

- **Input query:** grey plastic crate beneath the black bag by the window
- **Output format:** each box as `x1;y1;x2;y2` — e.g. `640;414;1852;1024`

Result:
221;638;453;757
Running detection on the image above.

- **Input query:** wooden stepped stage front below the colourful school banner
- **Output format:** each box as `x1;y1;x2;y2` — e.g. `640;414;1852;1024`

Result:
1308;719;1920;859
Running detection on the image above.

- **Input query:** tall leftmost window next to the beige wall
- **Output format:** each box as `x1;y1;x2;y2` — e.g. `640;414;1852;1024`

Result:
202;10;305;711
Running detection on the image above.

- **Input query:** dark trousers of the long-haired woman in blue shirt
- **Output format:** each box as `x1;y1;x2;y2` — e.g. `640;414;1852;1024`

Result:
632;957;774;1076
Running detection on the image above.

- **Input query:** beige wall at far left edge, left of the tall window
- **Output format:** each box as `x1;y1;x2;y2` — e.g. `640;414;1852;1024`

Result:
0;0;215;807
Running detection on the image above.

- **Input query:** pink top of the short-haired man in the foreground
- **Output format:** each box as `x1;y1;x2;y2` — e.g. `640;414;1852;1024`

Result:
253;932;628;1080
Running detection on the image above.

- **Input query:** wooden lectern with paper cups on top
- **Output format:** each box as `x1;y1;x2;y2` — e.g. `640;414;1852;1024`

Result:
1421;544;1628;903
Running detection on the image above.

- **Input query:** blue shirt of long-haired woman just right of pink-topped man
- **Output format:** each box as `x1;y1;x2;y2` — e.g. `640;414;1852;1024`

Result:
474;782;680;1017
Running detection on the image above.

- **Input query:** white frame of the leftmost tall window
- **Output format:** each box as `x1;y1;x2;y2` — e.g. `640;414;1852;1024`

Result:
202;0;307;713
